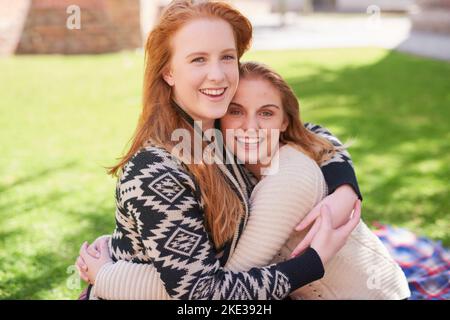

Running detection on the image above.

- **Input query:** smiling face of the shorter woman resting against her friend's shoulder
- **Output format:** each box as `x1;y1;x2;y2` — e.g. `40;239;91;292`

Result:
221;78;288;164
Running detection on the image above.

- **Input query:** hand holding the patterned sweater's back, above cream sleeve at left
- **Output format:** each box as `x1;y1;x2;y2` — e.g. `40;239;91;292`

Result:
76;236;112;284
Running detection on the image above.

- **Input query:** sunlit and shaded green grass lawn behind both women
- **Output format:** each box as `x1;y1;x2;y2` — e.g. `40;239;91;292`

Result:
0;49;450;299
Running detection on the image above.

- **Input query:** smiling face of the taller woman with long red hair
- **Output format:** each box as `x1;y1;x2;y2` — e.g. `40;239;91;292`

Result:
164;18;239;127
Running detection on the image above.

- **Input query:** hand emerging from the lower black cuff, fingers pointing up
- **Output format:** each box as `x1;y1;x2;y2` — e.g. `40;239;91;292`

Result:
291;199;361;265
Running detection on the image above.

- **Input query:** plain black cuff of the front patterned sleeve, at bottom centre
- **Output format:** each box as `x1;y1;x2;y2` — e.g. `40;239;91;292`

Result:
278;247;325;292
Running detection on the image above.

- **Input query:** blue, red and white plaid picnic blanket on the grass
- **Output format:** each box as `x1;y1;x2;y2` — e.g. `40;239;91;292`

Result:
374;223;450;300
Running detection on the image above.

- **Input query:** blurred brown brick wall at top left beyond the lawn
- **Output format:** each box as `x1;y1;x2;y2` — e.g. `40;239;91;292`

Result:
0;0;142;54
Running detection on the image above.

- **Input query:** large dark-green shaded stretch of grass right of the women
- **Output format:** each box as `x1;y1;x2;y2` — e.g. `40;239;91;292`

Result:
287;52;450;245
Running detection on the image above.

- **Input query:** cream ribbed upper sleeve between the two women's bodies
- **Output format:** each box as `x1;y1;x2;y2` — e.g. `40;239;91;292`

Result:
225;145;326;271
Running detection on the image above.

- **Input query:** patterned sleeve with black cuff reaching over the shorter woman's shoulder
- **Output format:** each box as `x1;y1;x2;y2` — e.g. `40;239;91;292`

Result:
305;123;362;200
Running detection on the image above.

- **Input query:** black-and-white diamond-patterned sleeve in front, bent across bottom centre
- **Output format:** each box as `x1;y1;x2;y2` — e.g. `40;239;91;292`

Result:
95;148;324;300
